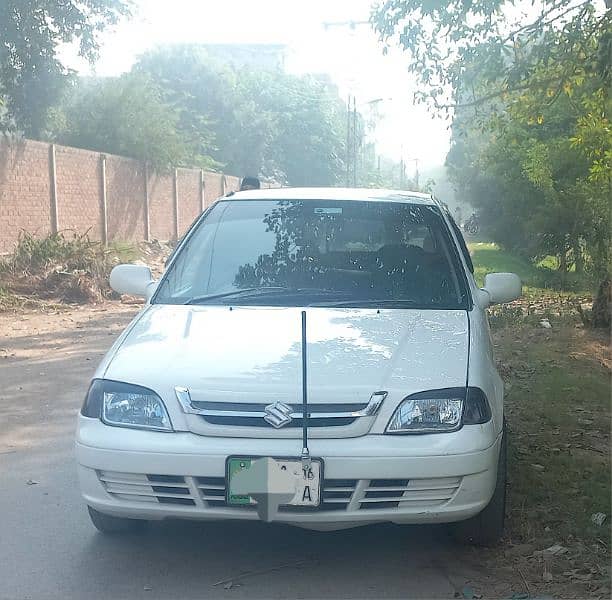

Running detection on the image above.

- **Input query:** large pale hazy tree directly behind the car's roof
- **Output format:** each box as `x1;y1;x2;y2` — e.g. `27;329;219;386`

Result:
135;45;346;185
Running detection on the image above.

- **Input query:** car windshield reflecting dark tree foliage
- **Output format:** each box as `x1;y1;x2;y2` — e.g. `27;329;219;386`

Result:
153;199;467;309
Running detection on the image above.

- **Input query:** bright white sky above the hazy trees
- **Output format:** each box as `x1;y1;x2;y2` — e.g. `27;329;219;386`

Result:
63;0;450;170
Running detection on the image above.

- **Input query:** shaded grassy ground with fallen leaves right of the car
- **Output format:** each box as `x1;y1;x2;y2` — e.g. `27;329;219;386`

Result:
495;326;612;586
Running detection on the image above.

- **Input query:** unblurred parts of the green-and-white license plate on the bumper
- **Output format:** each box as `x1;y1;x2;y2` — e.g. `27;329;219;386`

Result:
226;456;323;507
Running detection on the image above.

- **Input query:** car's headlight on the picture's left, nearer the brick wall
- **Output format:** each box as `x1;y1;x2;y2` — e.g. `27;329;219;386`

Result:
81;379;172;431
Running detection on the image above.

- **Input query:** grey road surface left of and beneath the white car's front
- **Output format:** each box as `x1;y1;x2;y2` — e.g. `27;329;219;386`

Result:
0;305;498;600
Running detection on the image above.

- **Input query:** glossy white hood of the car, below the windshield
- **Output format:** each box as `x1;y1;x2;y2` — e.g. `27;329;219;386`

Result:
101;305;469;403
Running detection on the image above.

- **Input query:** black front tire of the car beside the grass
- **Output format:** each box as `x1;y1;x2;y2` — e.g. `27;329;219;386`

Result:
450;423;507;546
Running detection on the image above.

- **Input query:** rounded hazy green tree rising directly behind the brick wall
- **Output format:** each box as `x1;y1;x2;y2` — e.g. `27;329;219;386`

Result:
54;73;212;170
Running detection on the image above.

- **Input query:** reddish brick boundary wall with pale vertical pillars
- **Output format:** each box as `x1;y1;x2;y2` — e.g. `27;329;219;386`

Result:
0;139;253;254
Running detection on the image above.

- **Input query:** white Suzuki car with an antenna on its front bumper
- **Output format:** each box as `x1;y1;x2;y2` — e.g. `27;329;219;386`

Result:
76;188;521;544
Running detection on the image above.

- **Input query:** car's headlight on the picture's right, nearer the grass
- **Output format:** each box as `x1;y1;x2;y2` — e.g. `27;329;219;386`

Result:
386;387;491;433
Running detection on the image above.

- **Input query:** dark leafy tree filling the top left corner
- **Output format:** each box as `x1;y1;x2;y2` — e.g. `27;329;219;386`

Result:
0;0;129;137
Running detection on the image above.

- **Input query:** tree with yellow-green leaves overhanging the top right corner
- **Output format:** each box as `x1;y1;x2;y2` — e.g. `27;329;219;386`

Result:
373;0;612;284
